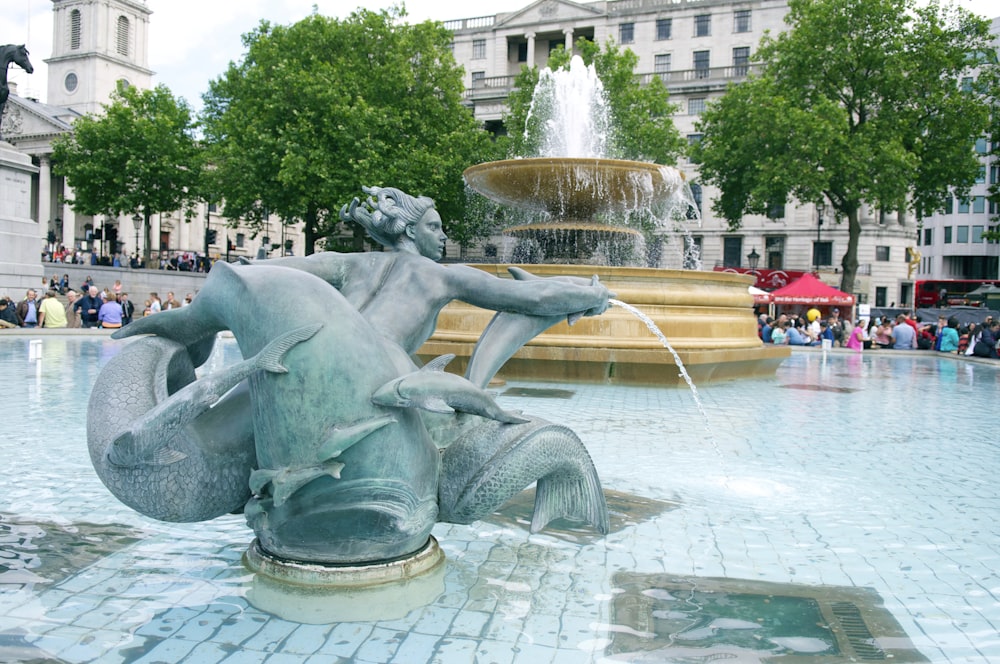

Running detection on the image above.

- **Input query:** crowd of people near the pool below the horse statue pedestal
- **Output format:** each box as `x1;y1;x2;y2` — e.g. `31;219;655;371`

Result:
0;275;194;330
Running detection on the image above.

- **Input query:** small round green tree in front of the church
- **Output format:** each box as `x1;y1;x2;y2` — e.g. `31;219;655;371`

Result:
52;85;204;261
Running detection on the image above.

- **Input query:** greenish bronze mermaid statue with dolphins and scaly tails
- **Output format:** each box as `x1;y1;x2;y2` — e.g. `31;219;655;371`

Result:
87;187;611;565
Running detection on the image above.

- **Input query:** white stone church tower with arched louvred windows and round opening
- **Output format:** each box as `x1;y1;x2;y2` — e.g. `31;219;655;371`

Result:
45;0;153;114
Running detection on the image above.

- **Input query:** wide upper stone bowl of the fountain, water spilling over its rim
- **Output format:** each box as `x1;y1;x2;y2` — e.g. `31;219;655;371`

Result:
464;157;684;220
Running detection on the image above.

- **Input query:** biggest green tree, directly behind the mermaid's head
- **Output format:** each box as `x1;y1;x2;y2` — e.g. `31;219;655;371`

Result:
203;8;492;253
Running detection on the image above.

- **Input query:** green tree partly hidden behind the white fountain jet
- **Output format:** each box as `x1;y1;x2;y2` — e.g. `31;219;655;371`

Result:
504;38;685;165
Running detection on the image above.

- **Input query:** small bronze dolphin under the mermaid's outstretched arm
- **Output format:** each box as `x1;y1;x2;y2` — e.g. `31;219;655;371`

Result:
372;353;528;424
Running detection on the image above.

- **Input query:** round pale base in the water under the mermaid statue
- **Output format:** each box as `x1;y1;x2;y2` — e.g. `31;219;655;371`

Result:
243;537;445;624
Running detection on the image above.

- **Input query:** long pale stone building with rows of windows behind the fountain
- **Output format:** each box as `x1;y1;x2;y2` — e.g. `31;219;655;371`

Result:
445;0;917;306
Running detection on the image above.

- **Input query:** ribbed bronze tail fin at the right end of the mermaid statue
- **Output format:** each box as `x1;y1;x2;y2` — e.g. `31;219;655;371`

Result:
531;469;611;535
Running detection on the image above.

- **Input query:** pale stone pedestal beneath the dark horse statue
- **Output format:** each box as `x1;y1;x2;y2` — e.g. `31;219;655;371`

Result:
0;141;43;301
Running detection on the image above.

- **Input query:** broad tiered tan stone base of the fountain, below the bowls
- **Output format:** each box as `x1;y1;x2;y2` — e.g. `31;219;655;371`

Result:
419;264;790;386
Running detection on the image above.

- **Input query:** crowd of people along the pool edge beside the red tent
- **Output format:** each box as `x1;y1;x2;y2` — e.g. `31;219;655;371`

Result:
757;309;1000;359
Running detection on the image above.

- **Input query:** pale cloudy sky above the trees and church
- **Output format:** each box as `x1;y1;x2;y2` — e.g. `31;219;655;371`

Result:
0;0;1000;115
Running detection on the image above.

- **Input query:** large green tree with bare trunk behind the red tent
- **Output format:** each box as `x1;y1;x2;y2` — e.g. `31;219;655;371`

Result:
694;0;990;292
